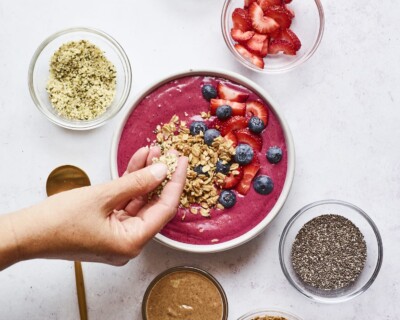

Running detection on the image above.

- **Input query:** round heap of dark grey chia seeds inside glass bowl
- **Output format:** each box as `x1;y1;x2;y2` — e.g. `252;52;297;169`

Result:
291;214;367;290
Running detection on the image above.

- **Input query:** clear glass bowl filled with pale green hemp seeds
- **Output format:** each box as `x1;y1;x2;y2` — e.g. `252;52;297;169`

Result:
28;27;132;130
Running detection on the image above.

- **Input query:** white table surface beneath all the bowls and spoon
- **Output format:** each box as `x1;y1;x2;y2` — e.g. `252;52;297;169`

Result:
0;0;400;320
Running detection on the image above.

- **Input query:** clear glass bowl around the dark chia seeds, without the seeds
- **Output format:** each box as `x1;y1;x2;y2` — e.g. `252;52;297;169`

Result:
279;200;383;303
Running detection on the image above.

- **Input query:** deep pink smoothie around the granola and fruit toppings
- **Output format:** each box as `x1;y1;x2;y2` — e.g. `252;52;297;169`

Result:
117;76;287;244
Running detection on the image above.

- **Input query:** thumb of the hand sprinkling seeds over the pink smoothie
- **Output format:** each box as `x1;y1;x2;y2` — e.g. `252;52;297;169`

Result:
104;163;168;207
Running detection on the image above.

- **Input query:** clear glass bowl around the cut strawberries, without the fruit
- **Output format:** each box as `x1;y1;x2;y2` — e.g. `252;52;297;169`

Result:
221;0;325;74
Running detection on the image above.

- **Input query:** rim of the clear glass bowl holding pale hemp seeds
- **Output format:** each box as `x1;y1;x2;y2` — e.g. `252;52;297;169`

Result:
28;26;132;130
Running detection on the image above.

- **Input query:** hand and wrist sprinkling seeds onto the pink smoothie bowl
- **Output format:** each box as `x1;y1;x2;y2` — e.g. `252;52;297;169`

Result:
0;147;187;269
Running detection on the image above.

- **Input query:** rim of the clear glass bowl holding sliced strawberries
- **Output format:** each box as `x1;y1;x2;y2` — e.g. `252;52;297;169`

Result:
221;0;325;74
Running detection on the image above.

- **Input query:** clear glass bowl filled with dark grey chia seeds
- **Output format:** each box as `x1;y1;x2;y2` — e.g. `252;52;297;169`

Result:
279;200;383;303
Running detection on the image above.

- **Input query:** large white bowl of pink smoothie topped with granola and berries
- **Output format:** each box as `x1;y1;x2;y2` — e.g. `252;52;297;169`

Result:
111;70;294;253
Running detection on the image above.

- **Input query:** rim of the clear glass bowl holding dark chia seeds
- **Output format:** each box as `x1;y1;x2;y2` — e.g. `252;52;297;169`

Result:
279;199;383;304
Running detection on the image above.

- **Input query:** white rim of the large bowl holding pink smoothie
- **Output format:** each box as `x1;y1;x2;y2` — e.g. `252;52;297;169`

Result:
110;69;295;253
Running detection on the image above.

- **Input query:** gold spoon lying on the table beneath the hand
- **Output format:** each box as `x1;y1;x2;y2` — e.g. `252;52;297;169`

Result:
46;165;90;320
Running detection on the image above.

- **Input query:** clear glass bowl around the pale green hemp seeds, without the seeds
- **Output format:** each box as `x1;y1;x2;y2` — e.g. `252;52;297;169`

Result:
28;27;132;130
